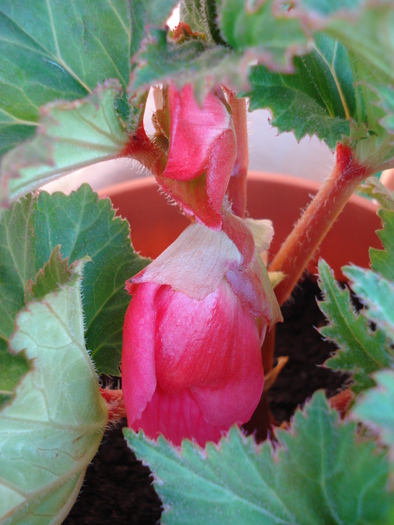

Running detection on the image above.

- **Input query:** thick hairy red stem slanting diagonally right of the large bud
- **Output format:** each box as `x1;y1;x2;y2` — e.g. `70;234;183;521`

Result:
269;144;371;305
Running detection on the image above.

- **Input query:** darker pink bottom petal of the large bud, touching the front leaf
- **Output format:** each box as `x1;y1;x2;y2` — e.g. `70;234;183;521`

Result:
131;387;227;447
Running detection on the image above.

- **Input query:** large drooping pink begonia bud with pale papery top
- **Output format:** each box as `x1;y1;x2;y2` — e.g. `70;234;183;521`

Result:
122;217;281;446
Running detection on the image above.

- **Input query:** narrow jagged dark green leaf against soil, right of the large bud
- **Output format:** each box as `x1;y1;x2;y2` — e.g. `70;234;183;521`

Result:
318;260;391;392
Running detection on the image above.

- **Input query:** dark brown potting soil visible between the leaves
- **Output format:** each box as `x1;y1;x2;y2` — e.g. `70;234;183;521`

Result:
64;279;347;525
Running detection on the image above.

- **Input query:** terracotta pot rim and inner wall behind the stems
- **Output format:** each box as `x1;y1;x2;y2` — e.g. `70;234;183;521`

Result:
100;172;381;279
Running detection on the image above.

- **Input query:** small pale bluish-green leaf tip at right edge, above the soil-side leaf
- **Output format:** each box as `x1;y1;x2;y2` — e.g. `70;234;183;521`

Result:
343;266;394;343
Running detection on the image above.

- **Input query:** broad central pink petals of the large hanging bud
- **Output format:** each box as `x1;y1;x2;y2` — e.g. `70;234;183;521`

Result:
156;282;264;426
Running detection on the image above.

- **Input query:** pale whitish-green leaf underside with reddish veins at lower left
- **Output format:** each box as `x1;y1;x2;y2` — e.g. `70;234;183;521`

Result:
0;260;108;525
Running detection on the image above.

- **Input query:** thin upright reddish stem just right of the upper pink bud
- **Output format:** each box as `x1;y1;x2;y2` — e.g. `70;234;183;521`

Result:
227;90;249;218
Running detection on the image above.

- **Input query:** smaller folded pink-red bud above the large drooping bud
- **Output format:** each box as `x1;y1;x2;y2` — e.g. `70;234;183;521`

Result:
156;84;237;230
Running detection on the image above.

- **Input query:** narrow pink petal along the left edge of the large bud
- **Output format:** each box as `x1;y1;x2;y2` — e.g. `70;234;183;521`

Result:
122;283;160;426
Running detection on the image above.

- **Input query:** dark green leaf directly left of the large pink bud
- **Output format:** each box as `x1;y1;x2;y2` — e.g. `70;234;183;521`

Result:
34;184;149;375
